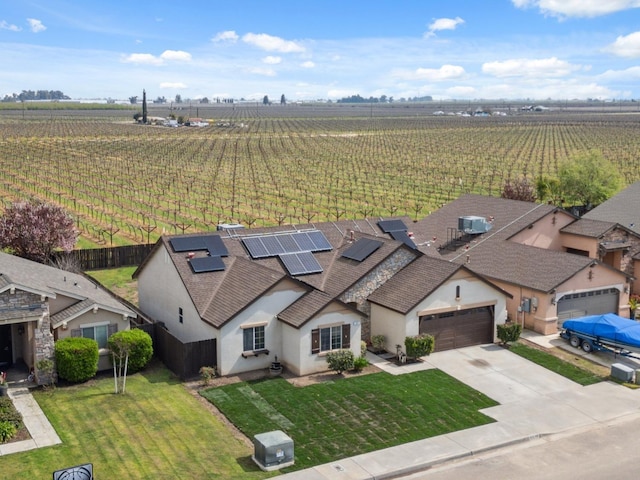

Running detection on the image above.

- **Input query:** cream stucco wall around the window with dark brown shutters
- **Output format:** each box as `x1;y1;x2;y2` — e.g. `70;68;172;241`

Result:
278;305;362;375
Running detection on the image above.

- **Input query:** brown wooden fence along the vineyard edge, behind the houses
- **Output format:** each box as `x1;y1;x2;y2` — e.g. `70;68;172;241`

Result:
52;243;154;271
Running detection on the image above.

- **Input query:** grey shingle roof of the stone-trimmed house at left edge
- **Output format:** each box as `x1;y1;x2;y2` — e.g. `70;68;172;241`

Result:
0;252;136;317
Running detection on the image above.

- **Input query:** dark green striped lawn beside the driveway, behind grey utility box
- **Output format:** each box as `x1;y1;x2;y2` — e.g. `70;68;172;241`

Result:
201;370;496;471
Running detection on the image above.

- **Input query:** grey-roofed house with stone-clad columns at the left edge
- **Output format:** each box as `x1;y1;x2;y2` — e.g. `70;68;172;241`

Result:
0;252;136;382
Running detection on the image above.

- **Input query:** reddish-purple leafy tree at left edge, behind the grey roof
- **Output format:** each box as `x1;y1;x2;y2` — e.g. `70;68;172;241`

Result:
0;202;78;262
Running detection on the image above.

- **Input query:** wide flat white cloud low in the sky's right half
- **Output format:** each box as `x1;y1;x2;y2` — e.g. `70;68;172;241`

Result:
482;57;583;78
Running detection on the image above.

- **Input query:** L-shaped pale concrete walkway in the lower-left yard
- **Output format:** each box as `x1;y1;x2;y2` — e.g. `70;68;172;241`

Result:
0;386;62;456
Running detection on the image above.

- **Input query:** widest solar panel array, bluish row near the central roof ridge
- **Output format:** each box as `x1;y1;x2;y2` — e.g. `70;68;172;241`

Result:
242;230;332;259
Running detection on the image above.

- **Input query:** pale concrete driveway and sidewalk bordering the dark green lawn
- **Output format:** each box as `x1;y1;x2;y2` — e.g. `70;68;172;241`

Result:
279;345;640;480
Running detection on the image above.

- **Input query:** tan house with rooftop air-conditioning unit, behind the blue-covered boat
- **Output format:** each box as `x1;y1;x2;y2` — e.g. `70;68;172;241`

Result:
412;195;632;334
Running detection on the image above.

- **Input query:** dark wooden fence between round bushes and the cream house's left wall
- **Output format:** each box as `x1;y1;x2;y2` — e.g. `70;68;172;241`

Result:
136;322;217;381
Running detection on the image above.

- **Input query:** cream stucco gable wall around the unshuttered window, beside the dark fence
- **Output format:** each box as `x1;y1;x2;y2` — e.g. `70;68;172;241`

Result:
217;281;306;375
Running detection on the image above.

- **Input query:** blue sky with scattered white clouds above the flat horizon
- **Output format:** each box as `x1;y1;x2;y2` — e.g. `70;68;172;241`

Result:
0;0;640;102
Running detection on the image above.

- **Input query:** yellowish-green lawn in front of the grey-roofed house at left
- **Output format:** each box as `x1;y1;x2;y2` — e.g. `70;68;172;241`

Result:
0;365;270;480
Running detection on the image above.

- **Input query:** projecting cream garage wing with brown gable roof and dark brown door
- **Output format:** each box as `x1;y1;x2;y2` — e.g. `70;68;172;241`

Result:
369;256;511;351
